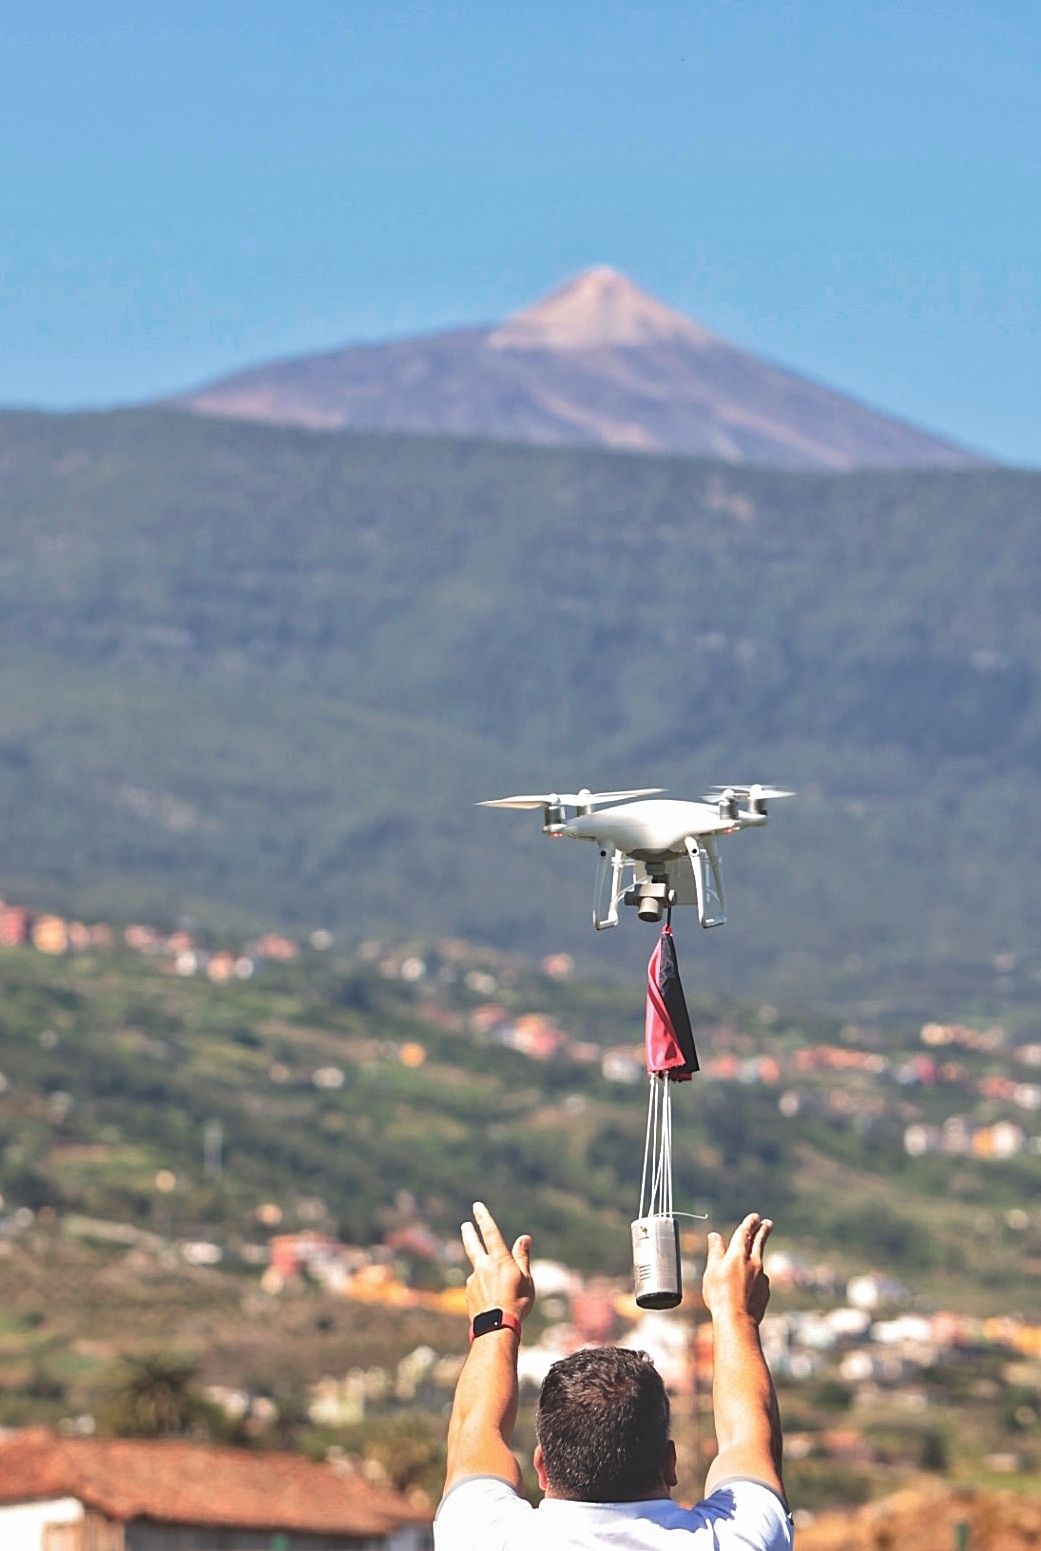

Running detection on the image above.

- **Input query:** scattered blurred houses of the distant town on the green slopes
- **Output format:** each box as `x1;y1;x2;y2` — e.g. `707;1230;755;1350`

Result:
0;903;1041;1472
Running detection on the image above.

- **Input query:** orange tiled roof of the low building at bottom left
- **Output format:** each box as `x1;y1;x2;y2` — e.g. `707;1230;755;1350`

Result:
0;1427;430;1537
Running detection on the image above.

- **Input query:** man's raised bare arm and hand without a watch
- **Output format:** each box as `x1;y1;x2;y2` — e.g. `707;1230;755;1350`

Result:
701;1213;785;1498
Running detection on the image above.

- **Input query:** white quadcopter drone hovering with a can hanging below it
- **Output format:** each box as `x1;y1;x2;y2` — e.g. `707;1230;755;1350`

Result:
478;786;793;932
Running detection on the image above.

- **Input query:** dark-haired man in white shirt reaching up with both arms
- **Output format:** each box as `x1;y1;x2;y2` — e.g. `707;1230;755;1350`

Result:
434;1202;791;1551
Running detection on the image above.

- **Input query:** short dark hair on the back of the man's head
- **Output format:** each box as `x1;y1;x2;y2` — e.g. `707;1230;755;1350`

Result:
535;1346;669;1503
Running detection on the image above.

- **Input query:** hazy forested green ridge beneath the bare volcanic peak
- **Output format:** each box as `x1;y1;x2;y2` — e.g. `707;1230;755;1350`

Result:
0;411;1041;1011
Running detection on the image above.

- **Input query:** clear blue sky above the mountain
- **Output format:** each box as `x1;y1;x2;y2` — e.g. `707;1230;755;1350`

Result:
0;0;1041;465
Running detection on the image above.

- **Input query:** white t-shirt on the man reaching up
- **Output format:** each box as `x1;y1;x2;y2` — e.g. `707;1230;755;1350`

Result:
434;1475;791;1551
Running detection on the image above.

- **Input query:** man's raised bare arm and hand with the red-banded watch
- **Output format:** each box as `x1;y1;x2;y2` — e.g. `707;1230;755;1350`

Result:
445;1200;535;1492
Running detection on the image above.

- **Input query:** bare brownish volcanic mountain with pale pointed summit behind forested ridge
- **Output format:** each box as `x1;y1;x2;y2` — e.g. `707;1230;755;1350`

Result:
178;265;980;468
